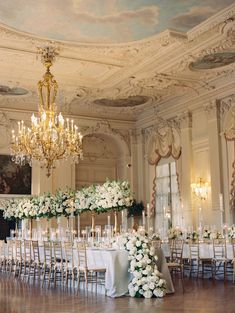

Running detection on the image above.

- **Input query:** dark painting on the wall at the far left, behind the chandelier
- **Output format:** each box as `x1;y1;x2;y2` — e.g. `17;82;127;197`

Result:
0;155;32;195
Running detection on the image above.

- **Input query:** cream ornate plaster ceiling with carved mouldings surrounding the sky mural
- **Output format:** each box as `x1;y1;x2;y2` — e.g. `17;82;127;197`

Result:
0;1;235;120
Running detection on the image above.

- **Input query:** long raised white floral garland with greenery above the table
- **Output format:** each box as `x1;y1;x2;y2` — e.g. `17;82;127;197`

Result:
1;181;133;220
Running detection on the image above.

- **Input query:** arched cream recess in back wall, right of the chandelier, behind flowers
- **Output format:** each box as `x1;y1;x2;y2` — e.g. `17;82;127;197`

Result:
75;123;130;230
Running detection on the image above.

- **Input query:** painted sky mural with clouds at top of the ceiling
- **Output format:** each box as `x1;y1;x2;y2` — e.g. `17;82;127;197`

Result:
0;0;234;43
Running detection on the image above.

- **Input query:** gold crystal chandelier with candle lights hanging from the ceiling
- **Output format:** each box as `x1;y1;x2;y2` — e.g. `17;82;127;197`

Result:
11;47;82;177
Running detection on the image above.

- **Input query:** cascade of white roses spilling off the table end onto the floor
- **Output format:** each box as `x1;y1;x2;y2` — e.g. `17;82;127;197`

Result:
118;233;166;298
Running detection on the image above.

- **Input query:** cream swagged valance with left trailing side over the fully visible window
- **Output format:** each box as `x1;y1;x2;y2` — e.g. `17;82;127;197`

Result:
147;120;181;222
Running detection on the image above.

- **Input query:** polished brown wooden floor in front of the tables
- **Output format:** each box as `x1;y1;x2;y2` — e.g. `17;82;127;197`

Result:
0;274;235;313
